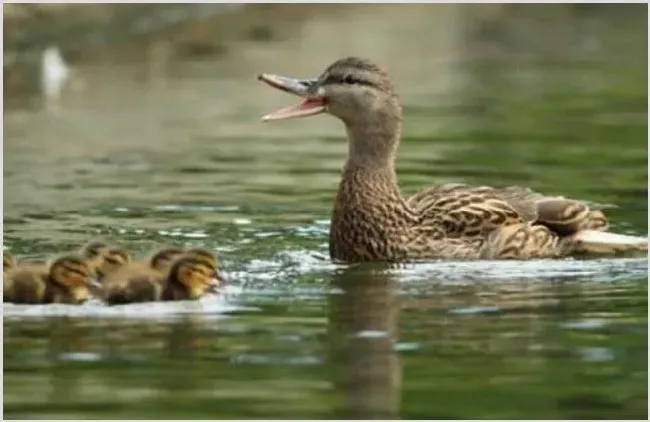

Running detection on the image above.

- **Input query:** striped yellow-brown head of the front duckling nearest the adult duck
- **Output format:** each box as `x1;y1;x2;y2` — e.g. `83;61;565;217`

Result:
168;256;220;300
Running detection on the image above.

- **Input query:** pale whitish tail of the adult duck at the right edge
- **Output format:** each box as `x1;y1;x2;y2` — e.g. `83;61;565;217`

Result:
562;230;648;256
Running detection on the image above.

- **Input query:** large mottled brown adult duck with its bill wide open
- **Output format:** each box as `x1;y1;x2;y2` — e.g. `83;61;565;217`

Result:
259;57;648;262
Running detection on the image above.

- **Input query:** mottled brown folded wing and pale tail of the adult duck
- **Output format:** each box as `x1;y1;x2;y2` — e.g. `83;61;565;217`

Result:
405;184;648;259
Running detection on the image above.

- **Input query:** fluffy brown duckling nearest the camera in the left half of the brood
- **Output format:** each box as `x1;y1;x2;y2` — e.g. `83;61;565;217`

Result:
3;255;95;304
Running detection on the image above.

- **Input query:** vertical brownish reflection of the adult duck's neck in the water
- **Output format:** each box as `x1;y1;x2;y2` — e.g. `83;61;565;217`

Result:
328;264;402;419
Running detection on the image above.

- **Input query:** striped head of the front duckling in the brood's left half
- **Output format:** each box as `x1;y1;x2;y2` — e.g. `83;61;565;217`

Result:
49;255;97;303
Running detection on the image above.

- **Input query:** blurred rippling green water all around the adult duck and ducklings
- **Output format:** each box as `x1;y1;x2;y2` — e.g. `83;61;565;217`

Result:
3;4;648;418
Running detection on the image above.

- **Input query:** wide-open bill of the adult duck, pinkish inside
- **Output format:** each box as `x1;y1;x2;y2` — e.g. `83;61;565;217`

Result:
257;73;325;122
